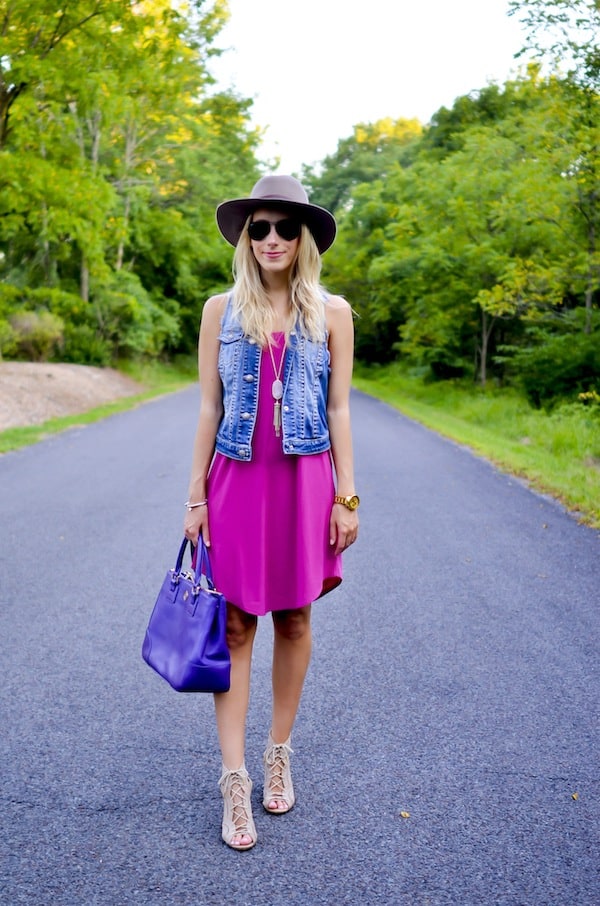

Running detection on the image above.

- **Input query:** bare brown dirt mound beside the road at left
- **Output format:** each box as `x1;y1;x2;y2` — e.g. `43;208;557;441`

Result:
0;362;143;431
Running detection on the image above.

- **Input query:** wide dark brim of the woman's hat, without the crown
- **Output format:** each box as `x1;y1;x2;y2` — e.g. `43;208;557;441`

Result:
216;198;337;254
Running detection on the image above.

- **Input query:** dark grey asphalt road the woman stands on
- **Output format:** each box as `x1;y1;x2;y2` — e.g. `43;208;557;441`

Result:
0;389;600;906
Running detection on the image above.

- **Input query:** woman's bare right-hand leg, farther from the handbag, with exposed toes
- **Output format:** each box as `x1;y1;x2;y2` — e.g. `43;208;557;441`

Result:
269;605;312;811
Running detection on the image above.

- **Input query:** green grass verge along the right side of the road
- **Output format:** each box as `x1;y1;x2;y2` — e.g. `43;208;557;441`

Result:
354;365;600;528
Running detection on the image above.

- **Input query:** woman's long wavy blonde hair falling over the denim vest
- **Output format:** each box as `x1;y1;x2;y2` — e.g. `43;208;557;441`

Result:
233;217;325;346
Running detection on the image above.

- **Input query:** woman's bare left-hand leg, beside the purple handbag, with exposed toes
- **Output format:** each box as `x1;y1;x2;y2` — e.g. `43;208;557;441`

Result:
214;604;257;848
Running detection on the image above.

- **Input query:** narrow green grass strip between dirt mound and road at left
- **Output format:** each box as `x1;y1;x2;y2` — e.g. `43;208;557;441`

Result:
0;358;198;453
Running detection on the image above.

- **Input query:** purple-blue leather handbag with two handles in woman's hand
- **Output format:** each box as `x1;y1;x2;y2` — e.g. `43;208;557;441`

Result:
142;538;231;692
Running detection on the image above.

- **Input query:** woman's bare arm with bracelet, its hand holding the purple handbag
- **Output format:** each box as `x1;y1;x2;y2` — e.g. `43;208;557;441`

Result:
184;296;226;546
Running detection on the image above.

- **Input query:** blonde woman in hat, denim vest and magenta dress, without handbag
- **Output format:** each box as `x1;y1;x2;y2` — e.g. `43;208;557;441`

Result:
184;175;358;850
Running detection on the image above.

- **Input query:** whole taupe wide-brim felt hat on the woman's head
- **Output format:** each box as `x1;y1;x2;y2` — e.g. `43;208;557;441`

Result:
216;175;337;254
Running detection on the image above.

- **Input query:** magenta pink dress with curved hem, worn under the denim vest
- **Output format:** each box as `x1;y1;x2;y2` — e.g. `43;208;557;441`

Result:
207;333;342;616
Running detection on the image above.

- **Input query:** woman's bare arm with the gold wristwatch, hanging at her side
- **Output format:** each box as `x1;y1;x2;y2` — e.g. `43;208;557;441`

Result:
327;296;358;553
